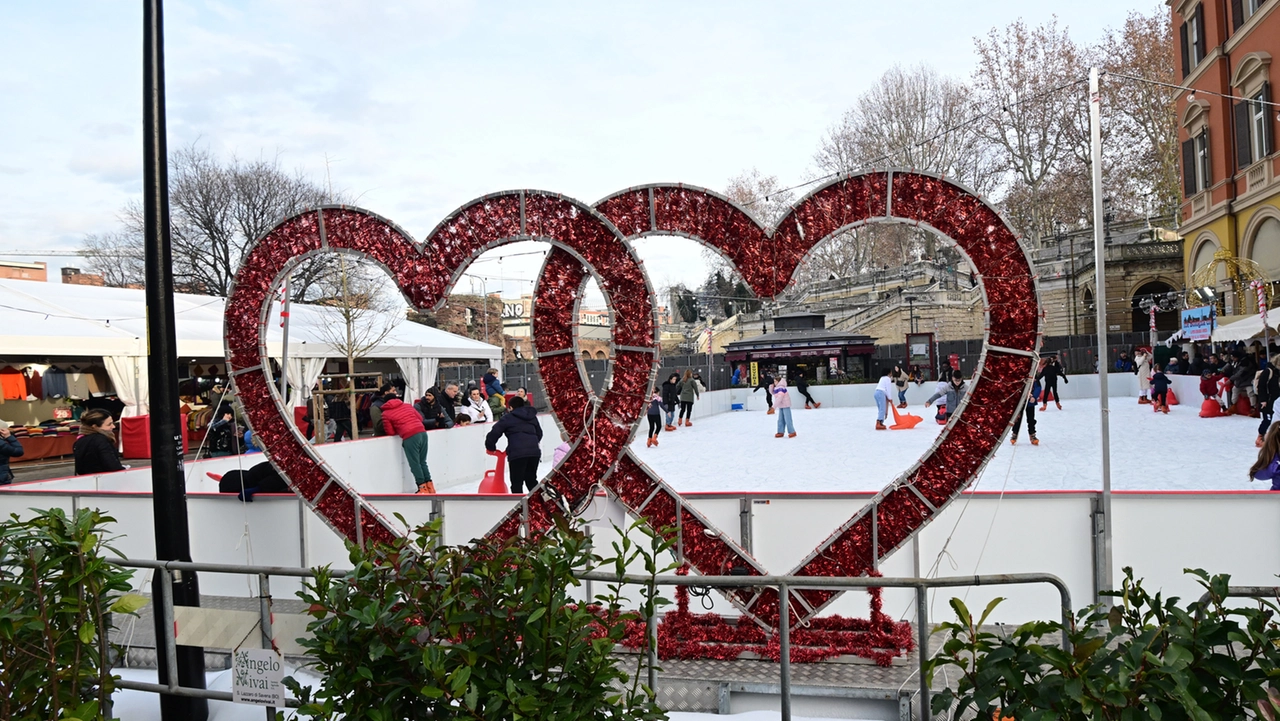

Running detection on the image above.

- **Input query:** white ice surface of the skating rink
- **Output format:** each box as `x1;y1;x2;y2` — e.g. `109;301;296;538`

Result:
631;397;1270;492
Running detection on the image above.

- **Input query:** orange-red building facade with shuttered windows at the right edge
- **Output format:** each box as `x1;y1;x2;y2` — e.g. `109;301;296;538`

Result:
1167;0;1280;309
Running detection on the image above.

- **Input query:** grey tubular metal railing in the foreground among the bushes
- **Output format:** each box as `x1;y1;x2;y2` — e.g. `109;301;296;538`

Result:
114;558;1070;721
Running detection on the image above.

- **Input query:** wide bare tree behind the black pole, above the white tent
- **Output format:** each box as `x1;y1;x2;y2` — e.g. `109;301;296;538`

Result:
82;145;342;301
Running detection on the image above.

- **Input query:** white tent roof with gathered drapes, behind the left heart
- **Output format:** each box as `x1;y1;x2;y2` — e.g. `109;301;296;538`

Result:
0;279;502;415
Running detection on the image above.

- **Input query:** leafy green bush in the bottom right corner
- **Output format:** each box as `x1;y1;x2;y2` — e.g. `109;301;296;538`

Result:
928;567;1280;721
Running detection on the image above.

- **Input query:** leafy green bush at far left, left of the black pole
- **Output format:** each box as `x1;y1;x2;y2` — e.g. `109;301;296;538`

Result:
0;508;146;720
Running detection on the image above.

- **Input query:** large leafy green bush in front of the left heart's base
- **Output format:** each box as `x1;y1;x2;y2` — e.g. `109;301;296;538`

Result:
285;519;668;721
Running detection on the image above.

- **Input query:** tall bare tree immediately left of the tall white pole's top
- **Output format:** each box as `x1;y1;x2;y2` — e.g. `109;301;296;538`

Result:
973;18;1087;241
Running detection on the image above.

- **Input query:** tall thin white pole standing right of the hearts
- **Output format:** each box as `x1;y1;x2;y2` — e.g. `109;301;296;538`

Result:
1089;68;1114;603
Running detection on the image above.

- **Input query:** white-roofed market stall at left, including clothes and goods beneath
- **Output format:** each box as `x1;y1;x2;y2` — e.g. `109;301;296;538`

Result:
0;279;502;461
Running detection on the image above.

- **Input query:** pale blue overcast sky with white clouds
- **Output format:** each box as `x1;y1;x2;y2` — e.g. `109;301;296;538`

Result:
0;0;1164;304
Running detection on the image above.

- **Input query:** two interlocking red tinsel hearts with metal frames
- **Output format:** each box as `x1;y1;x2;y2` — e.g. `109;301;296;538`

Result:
225;170;1041;637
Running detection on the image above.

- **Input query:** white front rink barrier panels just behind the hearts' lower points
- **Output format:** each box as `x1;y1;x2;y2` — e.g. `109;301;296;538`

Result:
0;484;1280;624
